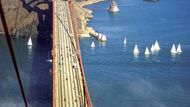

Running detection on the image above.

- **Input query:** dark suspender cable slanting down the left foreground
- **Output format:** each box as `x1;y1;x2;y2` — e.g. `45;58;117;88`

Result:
0;1;28;107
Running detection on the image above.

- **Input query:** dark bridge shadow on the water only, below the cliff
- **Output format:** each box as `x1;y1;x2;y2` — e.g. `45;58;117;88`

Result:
28;39;52;107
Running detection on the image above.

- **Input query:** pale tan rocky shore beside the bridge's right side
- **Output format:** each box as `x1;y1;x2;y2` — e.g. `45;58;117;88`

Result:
74;0;105;37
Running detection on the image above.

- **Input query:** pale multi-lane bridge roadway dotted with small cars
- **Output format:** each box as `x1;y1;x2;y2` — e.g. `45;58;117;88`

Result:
53;0;92;107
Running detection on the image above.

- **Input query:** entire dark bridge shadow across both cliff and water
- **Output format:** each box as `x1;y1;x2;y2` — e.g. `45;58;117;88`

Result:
18;0;52;107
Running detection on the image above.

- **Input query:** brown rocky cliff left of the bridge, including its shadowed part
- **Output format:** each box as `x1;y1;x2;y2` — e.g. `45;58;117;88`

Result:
0;0;52;36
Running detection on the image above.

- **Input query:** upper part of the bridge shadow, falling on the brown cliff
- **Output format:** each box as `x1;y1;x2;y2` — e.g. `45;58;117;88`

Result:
21;0;52;42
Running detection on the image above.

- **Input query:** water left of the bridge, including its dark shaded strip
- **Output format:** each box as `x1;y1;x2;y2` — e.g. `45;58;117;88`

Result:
0;35;52;107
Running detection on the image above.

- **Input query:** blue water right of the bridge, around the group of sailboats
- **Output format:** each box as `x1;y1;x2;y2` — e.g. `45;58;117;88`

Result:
80;0;190;107
